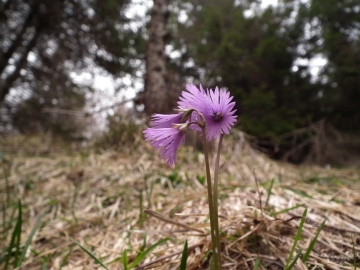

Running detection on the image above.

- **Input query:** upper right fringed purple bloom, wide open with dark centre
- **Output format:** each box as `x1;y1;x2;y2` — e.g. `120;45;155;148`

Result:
178;85;237;141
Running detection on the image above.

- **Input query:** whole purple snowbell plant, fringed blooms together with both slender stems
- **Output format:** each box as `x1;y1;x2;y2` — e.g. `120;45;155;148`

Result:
144;84;237;270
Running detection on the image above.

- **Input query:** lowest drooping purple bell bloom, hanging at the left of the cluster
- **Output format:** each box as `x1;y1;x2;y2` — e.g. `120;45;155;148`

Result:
144;128;185;166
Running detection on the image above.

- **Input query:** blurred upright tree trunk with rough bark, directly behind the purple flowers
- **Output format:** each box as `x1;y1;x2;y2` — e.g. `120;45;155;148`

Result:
143;0;169;115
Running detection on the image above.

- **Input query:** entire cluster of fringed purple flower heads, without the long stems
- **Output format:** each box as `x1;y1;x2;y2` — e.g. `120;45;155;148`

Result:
144;84;237;165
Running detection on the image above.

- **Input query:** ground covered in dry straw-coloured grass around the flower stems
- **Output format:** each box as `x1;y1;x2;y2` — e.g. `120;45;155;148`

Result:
0;132;360;270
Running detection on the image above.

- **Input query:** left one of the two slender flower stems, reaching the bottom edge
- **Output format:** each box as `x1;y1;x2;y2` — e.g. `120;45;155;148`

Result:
202;127;221;270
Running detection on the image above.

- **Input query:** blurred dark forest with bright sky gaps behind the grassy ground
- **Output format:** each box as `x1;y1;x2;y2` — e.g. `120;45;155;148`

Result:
0;0;360;165
